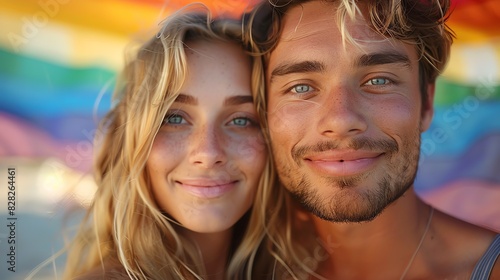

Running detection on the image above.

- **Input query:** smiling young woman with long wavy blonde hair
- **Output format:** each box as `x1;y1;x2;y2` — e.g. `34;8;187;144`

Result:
59;6;316;280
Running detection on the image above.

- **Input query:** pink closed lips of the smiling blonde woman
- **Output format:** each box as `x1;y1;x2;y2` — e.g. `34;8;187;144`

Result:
175;179;238;198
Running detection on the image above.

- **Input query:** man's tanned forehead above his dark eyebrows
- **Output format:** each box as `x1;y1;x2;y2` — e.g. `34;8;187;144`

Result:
267;1;418;78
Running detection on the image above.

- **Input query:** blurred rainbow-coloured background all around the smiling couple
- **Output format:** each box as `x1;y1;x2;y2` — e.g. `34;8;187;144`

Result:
0;0;500;280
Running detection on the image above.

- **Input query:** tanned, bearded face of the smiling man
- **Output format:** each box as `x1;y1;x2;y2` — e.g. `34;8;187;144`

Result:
266;1;433;222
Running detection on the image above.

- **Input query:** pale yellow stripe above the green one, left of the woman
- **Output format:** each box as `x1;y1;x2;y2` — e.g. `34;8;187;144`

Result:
0;11;131;71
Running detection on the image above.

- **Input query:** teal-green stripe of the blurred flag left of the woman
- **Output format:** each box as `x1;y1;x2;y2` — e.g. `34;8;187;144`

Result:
0;48;116;86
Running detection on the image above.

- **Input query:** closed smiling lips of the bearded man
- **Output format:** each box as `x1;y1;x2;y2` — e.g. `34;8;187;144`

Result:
304;150;384;177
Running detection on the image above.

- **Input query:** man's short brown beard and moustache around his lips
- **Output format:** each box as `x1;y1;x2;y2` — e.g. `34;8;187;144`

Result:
278;132;420;222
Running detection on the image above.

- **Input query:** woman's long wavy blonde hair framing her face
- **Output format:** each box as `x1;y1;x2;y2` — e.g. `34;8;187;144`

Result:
64;5;300;279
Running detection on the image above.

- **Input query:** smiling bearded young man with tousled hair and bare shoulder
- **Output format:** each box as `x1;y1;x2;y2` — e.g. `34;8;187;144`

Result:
252;0;500;280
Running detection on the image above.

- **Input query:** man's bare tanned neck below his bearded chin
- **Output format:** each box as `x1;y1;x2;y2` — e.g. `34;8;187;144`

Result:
313;188;431;279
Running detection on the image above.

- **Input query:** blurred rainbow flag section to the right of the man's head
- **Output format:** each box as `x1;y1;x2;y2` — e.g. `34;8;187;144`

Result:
415;0;500;231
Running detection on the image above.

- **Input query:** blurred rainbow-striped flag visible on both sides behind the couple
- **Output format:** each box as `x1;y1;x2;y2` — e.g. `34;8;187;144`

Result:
0;0;500;229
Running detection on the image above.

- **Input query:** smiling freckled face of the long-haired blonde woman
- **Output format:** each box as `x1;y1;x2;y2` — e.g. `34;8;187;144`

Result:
147;41;266;233
